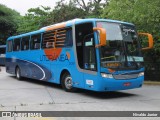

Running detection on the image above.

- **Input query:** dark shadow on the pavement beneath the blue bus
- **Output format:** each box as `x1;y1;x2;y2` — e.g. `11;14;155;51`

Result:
10;76;138;99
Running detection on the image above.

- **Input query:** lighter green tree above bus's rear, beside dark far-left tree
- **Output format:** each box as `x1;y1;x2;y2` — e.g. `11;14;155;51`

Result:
17;6;51;34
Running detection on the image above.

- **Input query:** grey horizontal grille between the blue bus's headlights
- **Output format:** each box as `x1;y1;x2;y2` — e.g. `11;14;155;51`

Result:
113;73;138;80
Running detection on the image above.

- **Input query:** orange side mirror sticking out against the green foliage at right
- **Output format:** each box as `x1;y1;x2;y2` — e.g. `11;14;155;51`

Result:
138;33;153;50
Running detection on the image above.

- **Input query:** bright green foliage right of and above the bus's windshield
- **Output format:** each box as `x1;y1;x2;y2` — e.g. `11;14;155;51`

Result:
101;0;160;61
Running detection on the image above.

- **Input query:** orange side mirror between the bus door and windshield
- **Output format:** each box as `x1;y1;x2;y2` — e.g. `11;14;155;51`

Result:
93;27;107;48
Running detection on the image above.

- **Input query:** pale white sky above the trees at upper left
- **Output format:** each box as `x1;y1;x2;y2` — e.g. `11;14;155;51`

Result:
0;0;59;15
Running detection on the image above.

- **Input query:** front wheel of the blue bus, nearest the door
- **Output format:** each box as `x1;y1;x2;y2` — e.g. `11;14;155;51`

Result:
61;73;76;92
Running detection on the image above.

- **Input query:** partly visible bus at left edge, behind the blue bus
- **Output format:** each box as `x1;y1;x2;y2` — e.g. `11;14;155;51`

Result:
0;45;6;66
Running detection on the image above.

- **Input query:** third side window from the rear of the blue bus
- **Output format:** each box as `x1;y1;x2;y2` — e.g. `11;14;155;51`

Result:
21;36;30;50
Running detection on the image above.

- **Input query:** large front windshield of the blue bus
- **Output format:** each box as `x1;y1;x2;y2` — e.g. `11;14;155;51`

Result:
97;22;143;69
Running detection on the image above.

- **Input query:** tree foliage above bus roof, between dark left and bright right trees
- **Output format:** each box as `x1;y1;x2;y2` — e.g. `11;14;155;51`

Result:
17;0;108;34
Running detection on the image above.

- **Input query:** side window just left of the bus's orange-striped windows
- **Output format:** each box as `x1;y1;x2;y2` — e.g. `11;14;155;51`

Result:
30;34;41;50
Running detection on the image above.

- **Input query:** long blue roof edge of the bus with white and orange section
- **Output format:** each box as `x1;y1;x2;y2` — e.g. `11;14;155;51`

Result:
7;18;134;40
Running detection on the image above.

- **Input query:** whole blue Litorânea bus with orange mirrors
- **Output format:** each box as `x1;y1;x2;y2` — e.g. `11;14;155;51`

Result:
6;18;153;92
